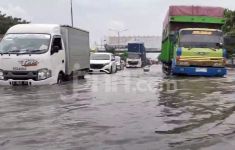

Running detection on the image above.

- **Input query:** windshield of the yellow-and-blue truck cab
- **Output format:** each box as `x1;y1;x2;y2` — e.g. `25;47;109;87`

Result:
179;30;223;48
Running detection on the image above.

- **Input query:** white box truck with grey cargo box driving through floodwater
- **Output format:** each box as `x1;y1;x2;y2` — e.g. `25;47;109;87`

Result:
0;24;90;85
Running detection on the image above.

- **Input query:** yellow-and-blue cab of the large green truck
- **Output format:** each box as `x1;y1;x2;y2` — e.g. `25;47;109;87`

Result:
172;28;226;76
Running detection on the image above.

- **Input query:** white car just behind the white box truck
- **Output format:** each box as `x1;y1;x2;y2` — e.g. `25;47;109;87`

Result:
90;53;117;74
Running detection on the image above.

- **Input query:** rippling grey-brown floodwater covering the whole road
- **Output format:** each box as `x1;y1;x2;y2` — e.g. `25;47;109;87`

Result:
0;66;235;150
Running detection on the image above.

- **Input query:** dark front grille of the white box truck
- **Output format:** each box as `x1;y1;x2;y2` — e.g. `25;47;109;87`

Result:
3;71;38;81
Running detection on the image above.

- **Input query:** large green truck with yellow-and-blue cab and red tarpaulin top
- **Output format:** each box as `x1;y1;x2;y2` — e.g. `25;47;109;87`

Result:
159;6;227;76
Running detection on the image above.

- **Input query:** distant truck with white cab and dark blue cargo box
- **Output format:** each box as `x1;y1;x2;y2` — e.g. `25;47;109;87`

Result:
126;42;146;68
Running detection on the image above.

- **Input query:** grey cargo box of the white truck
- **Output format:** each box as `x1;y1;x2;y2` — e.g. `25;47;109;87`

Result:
61;26;90;74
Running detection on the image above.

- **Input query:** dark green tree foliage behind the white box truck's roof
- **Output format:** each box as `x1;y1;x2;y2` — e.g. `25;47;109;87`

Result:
0;11;29;34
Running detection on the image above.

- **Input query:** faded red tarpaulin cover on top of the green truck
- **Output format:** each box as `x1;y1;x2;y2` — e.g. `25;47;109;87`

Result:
164;6;224;27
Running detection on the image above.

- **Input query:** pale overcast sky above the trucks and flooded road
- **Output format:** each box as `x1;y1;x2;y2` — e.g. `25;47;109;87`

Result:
0;0;235;46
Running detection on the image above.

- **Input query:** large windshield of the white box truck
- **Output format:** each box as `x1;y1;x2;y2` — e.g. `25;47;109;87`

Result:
0;34;50;54
